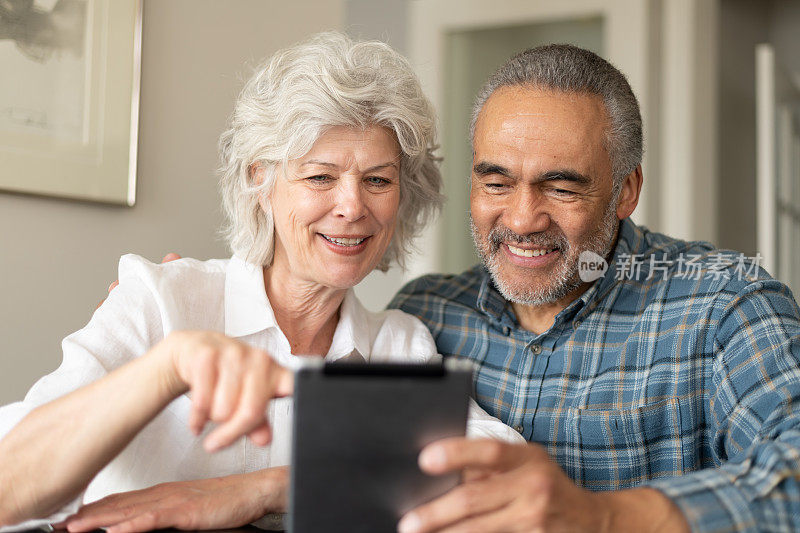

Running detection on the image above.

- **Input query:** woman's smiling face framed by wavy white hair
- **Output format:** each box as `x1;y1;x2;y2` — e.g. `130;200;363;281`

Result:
264;125;400;288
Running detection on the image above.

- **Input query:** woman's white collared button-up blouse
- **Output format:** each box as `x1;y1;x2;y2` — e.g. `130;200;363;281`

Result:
0;255;524;531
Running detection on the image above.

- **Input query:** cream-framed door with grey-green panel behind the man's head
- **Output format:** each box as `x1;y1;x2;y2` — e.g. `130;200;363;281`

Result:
406;0;658;278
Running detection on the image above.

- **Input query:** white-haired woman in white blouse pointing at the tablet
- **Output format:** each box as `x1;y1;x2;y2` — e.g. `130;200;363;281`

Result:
0;34;517;532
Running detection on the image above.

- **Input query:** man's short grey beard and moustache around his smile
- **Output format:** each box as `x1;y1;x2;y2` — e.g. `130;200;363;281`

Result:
470;198;619;306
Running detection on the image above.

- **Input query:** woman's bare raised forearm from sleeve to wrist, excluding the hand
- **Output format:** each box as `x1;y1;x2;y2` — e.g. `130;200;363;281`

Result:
0;345;181;525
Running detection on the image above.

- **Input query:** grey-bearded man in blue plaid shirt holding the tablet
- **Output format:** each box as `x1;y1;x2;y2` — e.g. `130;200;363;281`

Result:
391;45;800;533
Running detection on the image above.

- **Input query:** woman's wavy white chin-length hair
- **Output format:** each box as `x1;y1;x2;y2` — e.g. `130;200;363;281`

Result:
219;32;442;270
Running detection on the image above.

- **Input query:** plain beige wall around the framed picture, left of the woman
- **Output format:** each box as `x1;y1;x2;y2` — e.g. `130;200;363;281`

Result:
0;0;345;404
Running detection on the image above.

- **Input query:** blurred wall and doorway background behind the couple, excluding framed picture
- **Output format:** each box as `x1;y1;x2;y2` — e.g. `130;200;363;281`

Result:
0;0;800;404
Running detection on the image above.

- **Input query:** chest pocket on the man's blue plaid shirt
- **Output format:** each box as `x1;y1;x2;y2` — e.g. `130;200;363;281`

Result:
564;398;685;490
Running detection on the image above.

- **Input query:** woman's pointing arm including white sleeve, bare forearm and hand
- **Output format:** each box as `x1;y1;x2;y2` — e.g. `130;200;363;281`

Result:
0;258;291;526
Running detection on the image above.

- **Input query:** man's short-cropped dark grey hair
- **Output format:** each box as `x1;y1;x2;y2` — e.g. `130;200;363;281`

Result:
470;44;643;190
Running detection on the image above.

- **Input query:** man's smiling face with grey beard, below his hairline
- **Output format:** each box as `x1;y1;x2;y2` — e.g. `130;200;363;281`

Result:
470;87;629;305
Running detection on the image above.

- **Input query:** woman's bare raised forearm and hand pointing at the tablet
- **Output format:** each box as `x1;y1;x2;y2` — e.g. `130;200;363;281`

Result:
0;332;292;525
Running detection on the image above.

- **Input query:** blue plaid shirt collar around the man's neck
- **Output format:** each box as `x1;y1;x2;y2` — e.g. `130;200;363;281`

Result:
476;218;645;329
